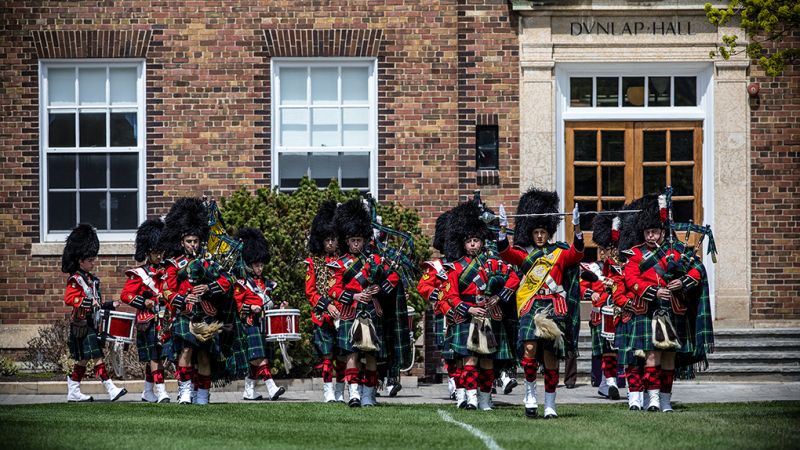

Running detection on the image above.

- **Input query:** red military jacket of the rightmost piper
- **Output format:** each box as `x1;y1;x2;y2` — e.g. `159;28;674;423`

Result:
624;244;702;314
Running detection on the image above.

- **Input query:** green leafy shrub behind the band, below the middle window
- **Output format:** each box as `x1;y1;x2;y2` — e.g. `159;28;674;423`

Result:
220;178;430;376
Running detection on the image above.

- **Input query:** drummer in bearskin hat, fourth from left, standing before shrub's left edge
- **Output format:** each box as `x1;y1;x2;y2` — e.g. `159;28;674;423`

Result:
233;228;288;400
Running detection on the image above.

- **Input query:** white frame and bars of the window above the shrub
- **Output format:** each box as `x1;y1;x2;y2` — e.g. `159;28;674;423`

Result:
270;57;378;196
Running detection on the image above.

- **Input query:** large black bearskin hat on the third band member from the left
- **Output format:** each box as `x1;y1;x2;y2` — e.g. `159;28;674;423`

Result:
159;197;211;258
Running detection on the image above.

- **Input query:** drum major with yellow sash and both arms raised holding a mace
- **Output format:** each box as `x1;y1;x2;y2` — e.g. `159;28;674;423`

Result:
497;188;584;419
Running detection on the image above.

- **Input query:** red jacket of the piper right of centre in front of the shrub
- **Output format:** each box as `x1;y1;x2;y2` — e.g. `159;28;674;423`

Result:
328;253;400;320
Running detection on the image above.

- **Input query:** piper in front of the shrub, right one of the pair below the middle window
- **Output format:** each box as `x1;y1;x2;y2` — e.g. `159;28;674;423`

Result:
328;199;399;407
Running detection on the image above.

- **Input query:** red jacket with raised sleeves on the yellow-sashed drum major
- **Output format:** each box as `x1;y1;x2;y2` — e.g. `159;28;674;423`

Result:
497;240;583;317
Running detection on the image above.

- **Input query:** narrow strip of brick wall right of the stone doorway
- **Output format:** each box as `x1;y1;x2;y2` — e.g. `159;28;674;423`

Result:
750;31;800;321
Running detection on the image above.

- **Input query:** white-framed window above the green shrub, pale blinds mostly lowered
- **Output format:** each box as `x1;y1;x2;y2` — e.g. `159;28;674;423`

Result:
272;58;378;195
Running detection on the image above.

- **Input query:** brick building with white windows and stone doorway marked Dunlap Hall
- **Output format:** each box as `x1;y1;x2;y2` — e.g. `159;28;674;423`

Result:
0;0;800;378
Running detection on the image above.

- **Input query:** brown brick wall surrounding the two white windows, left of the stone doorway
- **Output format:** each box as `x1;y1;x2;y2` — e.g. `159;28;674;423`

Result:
0;0;519;378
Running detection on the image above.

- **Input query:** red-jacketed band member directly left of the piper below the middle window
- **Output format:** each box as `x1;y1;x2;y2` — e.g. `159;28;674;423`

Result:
305;200;345;403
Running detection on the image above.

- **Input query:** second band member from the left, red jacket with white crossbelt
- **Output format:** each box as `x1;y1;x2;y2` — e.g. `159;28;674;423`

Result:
120;219;173;403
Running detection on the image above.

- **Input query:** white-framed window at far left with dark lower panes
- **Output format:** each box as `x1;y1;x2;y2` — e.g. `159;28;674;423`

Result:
39;59;145;242
